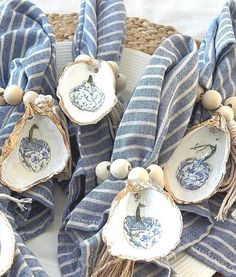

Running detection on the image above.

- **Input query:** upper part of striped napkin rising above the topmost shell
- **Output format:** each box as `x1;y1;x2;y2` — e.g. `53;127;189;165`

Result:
72;0;126;62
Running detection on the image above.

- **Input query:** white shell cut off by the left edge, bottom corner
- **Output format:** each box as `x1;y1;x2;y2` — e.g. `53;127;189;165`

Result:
0;212;15;276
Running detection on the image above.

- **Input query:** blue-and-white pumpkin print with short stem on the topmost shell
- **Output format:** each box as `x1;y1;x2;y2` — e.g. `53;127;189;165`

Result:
69;75;105;112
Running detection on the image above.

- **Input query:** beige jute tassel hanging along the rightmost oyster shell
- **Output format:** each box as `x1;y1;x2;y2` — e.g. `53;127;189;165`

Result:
216;120;236;221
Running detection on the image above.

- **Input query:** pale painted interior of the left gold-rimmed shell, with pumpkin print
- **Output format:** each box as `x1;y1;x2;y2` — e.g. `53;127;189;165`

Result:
1;114;69;192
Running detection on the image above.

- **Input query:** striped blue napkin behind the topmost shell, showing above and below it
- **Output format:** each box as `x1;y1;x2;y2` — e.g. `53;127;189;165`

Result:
65;0;126;214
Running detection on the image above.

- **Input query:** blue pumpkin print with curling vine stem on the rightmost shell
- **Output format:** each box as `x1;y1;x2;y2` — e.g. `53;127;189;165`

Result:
176;144;216;190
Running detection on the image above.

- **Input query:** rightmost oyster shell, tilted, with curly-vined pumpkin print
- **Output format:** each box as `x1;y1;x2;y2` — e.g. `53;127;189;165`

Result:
164;113;230;203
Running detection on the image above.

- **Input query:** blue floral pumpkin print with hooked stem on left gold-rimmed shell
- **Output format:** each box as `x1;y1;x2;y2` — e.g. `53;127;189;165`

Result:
19;124;51;173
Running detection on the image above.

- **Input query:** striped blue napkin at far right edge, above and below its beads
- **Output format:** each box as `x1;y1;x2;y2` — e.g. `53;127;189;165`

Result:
182;1;236;276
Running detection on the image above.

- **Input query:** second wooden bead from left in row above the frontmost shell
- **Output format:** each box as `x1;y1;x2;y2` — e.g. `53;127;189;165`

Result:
110;159;131;180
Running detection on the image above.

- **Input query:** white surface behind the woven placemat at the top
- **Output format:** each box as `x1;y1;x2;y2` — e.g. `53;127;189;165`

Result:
31;0;226;39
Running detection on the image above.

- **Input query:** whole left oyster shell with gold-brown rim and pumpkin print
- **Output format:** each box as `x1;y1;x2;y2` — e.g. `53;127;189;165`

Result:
0;95;70;192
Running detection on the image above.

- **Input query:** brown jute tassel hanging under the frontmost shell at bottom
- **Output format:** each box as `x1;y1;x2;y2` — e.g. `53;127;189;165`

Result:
91;245;135;277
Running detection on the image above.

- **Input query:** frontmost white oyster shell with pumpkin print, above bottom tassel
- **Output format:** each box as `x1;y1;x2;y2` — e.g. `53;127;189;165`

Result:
102;181;183;261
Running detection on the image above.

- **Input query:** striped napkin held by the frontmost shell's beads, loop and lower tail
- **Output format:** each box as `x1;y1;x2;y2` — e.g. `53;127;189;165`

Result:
58;35;198;277
